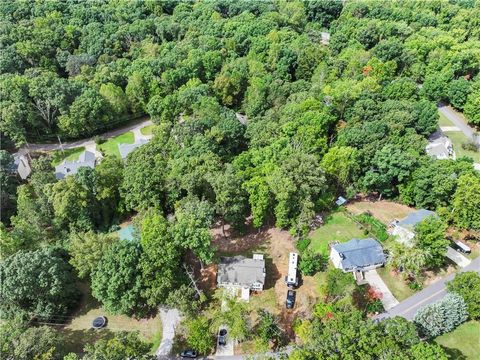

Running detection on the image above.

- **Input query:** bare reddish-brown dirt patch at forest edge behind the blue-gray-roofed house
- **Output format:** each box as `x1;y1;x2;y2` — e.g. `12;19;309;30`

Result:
347;200;415;225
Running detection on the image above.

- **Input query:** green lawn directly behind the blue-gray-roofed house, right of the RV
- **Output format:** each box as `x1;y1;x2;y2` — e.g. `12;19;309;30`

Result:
309;212;368;256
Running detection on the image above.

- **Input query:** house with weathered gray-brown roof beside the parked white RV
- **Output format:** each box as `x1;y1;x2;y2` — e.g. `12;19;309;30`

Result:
217;254;266;291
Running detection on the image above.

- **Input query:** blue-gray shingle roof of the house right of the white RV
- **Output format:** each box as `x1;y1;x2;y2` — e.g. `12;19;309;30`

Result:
333;238;386;271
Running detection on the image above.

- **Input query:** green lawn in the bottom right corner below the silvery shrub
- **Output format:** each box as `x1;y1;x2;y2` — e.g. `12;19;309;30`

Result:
435;320;480;360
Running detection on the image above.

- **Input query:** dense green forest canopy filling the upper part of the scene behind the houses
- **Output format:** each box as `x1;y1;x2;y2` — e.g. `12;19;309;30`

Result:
0;0;480;359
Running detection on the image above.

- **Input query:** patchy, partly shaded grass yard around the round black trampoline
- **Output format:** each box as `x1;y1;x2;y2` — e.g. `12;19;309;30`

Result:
60;284;162;353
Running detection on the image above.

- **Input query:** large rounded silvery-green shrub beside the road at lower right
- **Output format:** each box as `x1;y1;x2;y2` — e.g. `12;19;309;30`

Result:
413;294;468;338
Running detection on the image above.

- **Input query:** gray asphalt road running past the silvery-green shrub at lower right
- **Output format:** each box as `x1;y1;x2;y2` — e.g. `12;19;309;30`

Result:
374;257;480;320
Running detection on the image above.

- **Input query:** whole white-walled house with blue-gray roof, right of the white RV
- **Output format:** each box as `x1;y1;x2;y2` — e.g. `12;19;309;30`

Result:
330;238;386;277
